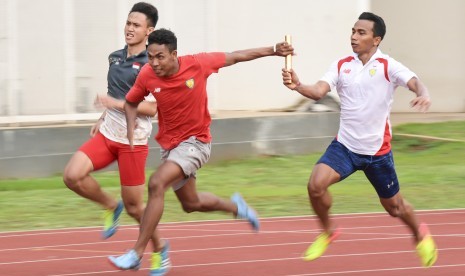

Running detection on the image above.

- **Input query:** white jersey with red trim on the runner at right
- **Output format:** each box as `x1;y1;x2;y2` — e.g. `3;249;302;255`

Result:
321;49;416;155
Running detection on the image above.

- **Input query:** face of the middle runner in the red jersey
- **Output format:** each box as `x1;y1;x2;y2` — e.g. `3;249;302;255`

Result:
147;43;178;77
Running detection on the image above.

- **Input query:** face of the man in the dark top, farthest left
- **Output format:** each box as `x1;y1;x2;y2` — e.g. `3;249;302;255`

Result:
124;12;153;46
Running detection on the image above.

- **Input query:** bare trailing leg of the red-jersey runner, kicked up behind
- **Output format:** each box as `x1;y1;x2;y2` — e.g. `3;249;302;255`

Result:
175;177;237;217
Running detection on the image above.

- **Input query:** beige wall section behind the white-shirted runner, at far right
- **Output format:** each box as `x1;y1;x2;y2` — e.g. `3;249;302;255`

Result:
372;0;465;112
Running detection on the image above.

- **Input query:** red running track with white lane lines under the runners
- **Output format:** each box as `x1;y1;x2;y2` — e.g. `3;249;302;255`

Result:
0;209;465;276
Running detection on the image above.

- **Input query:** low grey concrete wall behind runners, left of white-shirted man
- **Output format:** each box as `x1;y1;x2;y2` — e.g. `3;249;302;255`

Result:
0;113;339;178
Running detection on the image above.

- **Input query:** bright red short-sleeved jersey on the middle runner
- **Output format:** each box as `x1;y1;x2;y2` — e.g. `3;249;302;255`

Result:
126;53;226;150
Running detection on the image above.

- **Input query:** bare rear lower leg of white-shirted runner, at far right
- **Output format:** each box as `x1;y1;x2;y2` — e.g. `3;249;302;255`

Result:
380;192;423;243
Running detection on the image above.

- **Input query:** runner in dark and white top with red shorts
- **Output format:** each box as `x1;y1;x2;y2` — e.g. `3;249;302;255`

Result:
63;2;170;275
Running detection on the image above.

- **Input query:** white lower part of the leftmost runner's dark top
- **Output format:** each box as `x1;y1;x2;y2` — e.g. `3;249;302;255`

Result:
99;94;155;145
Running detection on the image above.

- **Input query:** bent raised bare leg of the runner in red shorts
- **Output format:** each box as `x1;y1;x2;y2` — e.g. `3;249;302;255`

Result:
63;151;118;210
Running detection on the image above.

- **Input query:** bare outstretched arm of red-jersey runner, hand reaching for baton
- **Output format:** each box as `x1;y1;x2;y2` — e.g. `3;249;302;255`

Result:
225;42;294;66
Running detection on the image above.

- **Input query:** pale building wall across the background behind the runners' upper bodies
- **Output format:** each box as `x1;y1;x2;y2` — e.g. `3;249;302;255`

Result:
0;0;465;123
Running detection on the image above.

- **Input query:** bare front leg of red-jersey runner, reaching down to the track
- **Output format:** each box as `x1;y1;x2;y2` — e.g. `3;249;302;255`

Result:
134;161;184;257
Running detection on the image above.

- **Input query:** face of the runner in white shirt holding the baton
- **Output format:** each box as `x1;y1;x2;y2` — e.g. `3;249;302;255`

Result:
350;20;381;55
